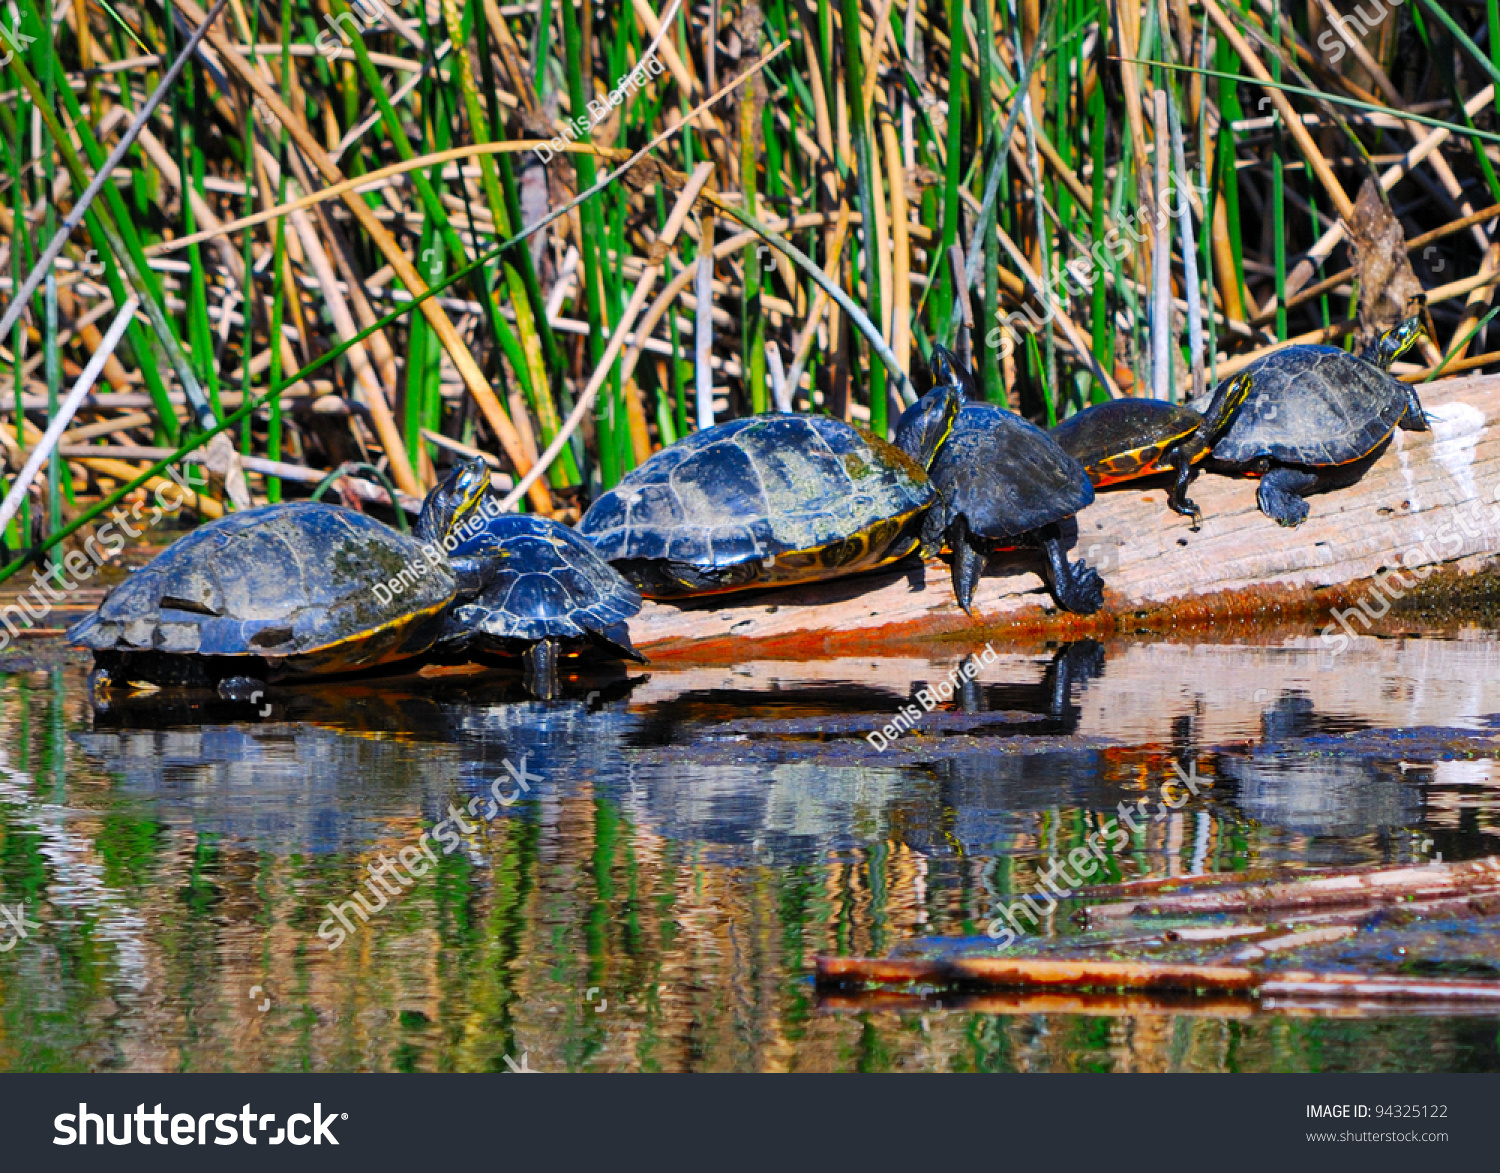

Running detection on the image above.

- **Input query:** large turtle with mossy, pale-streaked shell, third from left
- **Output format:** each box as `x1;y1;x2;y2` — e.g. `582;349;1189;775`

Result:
578;392;959;599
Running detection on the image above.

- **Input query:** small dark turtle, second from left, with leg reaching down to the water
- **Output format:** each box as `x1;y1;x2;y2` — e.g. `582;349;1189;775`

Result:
441;510;647;699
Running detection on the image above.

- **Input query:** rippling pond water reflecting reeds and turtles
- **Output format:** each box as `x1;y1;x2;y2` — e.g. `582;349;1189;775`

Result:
0;629;1500;1071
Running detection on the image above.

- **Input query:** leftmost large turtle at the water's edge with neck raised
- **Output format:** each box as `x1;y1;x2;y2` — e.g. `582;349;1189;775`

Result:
68;459;489;686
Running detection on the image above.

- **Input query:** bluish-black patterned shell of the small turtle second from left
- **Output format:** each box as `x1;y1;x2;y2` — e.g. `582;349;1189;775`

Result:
446;513;641;647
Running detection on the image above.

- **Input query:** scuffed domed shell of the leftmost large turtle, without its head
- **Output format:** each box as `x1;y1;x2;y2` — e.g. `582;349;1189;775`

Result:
68;503;456;671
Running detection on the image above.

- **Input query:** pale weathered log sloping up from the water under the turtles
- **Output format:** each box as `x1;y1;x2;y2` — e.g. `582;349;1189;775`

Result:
632;377;1500;659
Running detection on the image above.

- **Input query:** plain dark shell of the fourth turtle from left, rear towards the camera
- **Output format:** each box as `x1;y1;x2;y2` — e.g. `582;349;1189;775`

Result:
929;404;1094;540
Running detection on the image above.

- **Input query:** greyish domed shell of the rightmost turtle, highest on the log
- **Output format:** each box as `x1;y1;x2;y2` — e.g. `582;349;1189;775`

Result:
1214;345;1421;468
